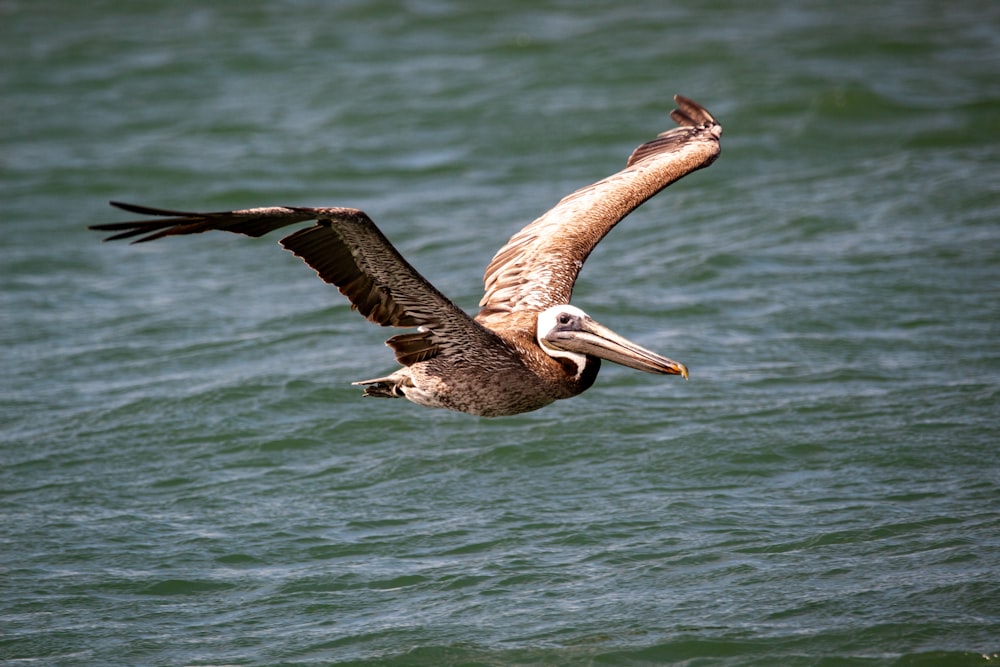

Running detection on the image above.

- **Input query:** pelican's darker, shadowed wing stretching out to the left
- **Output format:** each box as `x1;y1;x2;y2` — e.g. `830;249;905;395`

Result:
91;202;504;365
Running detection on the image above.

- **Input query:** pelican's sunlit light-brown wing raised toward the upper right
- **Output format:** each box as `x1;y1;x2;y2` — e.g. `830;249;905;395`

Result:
476;95;722;326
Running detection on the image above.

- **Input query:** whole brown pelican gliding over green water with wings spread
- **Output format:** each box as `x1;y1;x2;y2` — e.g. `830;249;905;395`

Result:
91;95;722;417
